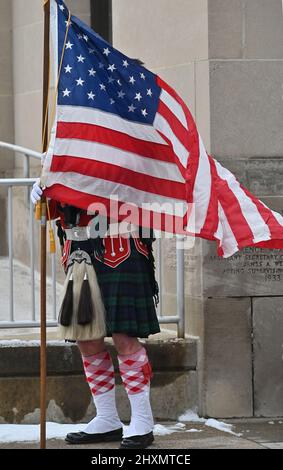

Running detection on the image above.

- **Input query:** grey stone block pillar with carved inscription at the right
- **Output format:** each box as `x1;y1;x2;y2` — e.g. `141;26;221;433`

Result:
194;0;283;417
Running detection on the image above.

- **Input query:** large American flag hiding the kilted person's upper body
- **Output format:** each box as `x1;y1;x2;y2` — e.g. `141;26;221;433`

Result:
42;0;283;257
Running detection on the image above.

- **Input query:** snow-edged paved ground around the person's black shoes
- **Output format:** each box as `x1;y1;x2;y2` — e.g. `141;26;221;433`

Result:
0;419;283;450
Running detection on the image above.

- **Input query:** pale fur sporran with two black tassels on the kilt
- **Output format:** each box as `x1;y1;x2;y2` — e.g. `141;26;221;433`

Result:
58;250;106;341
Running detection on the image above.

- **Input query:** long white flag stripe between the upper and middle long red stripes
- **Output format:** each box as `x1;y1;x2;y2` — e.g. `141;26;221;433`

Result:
54;138;184;183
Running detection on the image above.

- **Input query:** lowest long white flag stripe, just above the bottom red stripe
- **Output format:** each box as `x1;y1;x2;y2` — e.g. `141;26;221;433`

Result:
46;172;187;216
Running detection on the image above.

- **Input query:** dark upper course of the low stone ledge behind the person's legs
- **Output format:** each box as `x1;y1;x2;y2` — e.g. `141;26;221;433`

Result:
0;339;197;377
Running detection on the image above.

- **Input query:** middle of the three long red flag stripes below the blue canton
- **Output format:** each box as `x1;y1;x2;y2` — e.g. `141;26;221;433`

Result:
50;155;186;201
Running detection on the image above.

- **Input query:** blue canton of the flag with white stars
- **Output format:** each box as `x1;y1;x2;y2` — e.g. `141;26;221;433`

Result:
57;1;161;124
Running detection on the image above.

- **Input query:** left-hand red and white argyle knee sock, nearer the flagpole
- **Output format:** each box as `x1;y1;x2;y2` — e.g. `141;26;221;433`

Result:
83;351;122;434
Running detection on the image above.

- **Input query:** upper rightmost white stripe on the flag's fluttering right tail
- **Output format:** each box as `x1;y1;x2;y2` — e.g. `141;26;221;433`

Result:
214;160;271;243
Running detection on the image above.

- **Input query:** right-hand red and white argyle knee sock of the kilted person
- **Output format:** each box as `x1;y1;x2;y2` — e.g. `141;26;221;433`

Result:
118;347;154;437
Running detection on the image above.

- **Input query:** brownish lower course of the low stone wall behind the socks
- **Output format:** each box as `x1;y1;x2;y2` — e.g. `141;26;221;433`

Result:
0;371;198;424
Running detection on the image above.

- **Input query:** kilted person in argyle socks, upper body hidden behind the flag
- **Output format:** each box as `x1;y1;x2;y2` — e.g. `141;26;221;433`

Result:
31;182;160;449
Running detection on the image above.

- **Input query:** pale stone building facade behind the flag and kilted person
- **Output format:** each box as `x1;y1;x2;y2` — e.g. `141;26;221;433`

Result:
0;0;283;417
